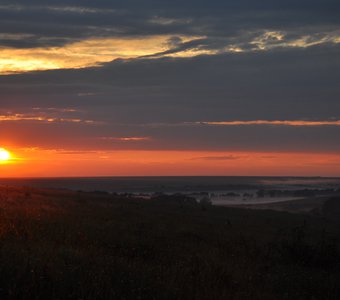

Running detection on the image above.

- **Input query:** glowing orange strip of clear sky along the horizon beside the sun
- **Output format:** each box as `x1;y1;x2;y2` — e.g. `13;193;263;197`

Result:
0;146;340;178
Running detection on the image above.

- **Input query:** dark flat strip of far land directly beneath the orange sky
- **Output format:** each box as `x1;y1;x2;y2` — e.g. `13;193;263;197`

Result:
0;176;340;193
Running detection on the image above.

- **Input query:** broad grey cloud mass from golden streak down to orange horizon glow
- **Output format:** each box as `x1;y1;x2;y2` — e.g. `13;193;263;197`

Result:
0;37;340;157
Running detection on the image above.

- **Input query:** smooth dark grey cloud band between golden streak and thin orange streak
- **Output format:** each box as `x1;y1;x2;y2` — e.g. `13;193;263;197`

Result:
0;45;340;118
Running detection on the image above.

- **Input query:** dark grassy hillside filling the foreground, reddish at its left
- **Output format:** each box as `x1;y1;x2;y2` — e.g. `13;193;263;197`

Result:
0;188;340;300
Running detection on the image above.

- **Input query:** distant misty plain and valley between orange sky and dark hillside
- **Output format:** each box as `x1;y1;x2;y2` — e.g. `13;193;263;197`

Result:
0;176;340;213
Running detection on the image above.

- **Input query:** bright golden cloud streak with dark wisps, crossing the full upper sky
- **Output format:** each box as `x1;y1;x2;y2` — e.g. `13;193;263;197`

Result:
0;30;340;75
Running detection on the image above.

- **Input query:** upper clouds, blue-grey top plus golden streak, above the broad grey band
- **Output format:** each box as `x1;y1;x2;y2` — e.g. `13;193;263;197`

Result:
0;0;340;74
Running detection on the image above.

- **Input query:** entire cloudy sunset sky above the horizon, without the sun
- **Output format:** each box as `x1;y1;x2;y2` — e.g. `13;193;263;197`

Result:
0;0;340;177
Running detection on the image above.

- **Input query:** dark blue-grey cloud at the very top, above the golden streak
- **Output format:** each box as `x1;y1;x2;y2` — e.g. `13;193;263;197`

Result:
0;0;340;48
